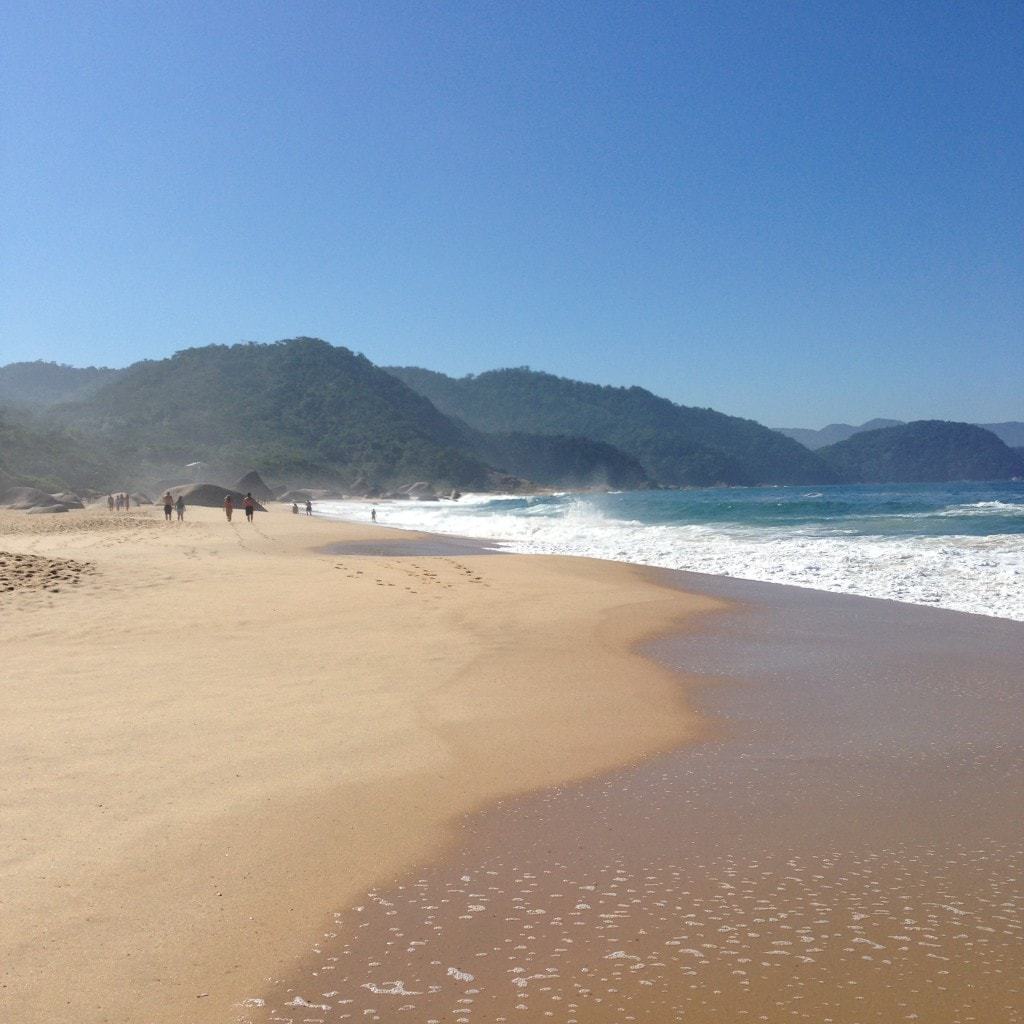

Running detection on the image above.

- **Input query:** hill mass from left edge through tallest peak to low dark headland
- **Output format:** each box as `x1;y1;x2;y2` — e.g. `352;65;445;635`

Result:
0;338;651;492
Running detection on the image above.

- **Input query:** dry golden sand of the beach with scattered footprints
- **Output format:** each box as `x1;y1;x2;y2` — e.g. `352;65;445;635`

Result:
0;508;720;1024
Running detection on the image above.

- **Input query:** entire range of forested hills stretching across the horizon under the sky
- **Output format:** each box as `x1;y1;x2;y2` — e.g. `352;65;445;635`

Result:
0;348;1024;493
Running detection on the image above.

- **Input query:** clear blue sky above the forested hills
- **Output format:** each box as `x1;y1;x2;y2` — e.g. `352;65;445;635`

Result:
0;0;1024;426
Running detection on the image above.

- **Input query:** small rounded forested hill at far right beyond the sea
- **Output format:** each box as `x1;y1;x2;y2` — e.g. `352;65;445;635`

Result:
818;420;1024;483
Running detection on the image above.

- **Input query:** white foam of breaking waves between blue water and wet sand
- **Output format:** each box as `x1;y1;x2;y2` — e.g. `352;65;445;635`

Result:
317;495;1024;621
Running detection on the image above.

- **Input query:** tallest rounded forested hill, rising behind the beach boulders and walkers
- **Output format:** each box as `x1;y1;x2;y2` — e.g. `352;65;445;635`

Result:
54;338;487;488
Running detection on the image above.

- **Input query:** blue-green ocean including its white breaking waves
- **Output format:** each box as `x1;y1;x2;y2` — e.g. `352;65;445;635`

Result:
316;481;1024;621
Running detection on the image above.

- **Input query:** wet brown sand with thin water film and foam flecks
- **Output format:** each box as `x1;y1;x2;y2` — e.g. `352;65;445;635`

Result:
239;573;1024;1024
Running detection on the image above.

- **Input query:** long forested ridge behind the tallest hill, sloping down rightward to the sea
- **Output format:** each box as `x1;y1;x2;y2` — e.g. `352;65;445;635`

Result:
388;367;837;485
